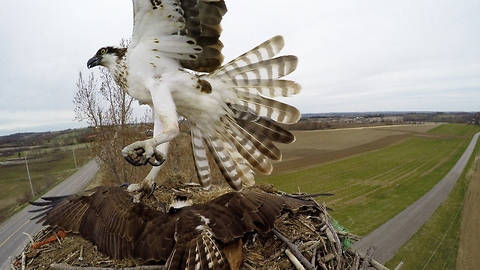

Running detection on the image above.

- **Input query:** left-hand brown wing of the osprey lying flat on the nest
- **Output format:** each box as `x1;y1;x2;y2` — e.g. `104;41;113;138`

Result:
31;187;174;261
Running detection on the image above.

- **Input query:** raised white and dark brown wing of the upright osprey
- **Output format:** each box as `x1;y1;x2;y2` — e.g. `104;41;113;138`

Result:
130;0;227;72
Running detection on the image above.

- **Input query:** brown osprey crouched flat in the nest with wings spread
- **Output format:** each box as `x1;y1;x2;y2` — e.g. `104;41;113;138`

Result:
31;186;316;269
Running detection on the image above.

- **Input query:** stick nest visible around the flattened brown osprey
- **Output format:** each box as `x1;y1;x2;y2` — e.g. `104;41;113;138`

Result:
12;184;387;269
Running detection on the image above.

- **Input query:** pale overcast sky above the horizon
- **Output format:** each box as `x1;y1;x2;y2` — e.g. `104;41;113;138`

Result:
0;0;480;136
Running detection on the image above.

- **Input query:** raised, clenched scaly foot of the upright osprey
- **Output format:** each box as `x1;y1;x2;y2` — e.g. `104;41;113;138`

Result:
122;141;166;166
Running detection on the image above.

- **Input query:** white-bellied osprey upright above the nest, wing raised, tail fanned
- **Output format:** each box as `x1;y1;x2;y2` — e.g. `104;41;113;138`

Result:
87;0;301;194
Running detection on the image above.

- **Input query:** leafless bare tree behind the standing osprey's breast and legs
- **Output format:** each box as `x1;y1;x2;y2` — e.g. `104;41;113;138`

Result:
73;69;151;184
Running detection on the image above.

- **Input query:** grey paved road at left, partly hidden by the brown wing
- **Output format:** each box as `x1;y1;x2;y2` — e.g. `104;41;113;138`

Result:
0;160;98;270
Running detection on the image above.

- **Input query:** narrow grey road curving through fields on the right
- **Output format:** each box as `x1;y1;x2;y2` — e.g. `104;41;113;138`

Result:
354;133;480;263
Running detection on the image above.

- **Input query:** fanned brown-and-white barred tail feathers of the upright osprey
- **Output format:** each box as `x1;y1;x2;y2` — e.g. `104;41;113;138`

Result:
188;36;301;190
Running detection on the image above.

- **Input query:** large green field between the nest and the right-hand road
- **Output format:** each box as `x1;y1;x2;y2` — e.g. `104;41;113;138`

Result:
261;125;480;235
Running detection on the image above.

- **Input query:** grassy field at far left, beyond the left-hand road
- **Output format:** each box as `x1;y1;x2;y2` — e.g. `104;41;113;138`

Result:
0;131;91;222
